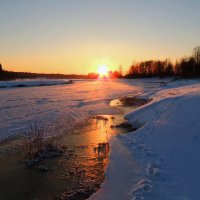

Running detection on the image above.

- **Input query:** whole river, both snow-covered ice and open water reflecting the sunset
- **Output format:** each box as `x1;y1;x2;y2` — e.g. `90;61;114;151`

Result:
0;79;165;199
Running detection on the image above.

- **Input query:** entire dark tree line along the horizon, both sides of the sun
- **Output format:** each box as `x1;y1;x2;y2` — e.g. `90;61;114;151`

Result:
0;57;200;81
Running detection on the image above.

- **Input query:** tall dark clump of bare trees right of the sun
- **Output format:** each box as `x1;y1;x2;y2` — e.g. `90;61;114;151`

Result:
125;57;200;78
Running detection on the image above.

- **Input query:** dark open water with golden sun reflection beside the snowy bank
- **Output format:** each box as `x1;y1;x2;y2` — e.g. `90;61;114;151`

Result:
0;112;130;200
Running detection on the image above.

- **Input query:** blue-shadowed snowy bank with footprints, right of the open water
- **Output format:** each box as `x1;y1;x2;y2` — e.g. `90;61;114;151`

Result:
89;80;200;200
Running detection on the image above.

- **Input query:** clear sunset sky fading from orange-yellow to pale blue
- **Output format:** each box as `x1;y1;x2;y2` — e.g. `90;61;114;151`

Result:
0;0;200;74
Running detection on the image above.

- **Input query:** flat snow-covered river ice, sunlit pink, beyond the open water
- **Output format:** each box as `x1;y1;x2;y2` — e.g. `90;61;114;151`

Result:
0;80;160;138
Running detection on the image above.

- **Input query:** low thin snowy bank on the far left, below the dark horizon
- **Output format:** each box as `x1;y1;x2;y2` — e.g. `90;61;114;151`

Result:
0;79;72;88
